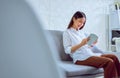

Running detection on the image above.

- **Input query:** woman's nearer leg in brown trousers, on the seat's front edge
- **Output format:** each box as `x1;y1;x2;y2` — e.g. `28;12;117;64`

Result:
75;56;117;78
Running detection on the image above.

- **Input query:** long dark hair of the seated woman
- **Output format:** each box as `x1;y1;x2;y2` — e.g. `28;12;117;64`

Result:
67;11;86;30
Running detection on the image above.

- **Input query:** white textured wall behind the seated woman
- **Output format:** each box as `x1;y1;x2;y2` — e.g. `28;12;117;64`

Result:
27;0;114;50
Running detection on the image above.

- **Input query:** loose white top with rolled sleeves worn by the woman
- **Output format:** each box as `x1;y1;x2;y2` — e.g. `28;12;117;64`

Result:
63;28;101;63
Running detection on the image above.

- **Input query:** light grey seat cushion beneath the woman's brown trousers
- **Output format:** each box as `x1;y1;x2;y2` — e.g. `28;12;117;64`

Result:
60;61;103;76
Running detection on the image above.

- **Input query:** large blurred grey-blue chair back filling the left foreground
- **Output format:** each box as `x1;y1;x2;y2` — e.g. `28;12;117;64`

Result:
0;0;64;78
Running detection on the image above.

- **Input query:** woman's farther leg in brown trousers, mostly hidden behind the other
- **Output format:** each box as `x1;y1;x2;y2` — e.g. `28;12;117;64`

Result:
102;54;120;77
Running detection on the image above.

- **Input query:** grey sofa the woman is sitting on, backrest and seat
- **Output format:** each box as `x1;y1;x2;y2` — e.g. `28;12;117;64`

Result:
47;30;104;78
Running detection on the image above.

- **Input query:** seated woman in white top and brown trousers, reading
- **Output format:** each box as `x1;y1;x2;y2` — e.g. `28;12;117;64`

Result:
63;11;120;78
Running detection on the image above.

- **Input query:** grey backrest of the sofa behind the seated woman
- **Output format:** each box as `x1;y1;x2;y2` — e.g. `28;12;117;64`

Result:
47;30;72;61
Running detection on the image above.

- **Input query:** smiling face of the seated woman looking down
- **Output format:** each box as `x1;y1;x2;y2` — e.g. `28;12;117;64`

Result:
73;17;86;30
